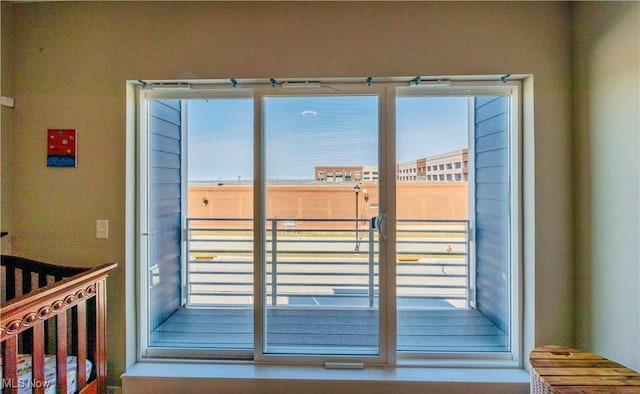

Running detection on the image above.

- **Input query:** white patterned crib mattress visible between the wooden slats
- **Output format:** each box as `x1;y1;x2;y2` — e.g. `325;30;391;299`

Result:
0;354;92;394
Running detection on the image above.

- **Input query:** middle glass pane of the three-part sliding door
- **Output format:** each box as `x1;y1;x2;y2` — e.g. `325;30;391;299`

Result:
262;95;380;356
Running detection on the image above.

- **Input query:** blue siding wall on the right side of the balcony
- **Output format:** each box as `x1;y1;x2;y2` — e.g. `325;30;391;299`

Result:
474;96;510;334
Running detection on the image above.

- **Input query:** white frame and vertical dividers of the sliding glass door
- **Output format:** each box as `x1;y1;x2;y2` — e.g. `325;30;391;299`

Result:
135;81;524;367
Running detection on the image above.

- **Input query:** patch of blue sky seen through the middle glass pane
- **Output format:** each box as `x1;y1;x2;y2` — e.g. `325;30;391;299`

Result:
265;96;379;179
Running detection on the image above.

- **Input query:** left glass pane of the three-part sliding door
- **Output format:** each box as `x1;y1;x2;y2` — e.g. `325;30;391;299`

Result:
148;97;254;350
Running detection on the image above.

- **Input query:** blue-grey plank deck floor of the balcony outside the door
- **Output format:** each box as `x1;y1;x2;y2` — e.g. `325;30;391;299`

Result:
150;308;509;354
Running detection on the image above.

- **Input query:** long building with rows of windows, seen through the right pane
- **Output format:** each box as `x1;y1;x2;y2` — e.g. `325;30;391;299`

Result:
396;149;469;182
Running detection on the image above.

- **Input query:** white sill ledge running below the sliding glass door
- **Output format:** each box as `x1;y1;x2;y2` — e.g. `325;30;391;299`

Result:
122;362;529;393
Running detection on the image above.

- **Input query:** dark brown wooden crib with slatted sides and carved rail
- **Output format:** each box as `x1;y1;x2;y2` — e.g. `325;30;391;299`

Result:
0;255;116;394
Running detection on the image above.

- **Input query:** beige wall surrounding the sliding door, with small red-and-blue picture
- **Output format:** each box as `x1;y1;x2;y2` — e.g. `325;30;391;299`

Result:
3;2;573;384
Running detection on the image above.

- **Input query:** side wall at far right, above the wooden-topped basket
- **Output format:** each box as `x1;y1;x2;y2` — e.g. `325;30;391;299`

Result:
574;2;640;370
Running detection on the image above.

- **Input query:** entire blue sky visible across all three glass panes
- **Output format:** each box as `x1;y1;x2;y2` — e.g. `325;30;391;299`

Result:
187;95;468;181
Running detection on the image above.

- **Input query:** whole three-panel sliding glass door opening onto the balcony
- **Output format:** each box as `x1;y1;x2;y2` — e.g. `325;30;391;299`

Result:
138;81;521;367
